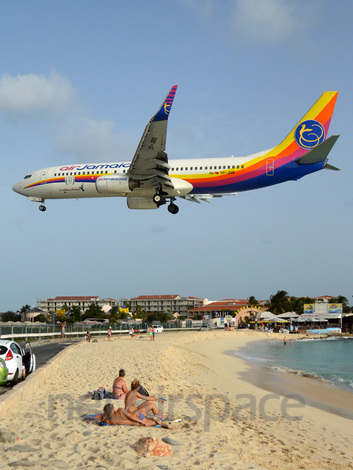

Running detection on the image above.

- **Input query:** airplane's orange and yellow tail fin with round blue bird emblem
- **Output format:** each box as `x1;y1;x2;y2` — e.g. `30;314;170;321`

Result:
267;91;338;165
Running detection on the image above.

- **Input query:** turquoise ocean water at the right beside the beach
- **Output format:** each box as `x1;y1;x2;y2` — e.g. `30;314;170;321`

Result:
235;336;353;393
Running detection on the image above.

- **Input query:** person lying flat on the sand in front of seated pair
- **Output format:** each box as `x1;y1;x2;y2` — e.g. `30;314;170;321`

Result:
101;403;175;429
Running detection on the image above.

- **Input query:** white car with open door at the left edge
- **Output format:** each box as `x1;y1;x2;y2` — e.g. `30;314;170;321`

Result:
0;339;36;385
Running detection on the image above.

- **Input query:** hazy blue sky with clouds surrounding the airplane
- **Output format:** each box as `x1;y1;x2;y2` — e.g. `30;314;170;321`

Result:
0;0;353;312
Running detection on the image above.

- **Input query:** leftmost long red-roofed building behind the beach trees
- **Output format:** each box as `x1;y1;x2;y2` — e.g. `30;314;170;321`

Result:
37;295;123;313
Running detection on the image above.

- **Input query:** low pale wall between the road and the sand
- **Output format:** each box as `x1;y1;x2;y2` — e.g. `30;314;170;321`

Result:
0;343;80;419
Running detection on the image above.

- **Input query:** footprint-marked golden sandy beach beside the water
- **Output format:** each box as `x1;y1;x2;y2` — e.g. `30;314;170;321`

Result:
0;331;353;470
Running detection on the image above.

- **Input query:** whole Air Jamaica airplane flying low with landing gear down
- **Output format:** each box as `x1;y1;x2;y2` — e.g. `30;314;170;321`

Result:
12;85;339;214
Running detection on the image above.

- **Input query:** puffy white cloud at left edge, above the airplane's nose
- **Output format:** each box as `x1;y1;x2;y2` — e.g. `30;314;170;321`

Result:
0;72;73;120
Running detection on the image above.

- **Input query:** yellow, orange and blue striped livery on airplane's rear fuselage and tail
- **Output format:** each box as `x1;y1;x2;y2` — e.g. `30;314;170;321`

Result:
171;91;338;194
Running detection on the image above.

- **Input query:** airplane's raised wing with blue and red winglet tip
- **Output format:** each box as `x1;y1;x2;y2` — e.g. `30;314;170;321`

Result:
127;85;178;194
